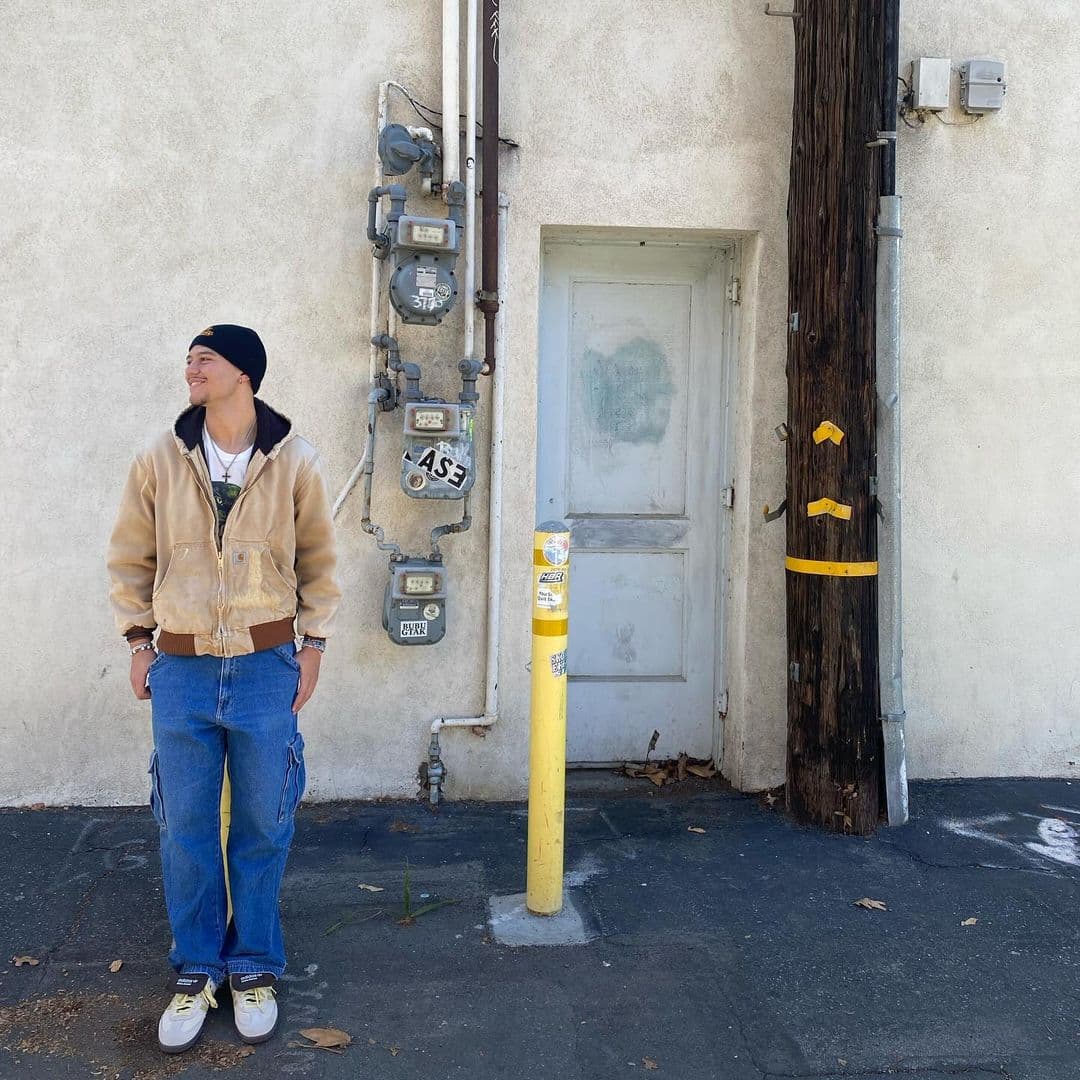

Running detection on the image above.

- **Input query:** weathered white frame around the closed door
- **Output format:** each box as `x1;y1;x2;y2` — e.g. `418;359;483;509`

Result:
534;226;744;770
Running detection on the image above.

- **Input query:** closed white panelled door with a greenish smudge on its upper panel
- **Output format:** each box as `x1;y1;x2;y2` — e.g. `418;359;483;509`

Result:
537;241;731;764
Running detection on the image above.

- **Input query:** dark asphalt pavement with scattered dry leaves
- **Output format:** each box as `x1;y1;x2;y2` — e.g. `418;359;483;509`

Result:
0;777;1080;1080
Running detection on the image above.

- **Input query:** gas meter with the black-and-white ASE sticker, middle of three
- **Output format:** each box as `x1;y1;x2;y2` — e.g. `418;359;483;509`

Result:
402;401;476;499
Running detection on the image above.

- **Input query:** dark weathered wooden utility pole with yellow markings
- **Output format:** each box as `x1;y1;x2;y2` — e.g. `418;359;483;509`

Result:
786;0;882;834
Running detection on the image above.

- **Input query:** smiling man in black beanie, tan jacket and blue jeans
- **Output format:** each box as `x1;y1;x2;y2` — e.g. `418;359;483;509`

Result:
109;325;340;1053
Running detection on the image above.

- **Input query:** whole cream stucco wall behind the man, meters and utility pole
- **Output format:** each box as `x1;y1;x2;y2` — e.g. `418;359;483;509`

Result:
0;0;1080;802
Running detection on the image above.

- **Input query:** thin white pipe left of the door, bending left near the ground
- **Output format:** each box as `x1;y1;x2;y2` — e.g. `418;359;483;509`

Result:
428;195;510;806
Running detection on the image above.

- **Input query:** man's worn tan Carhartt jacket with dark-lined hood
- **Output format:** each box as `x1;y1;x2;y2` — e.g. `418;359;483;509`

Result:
108;400;340;657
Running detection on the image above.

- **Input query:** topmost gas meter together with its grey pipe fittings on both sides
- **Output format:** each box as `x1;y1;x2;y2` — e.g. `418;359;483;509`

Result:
367;180;464;326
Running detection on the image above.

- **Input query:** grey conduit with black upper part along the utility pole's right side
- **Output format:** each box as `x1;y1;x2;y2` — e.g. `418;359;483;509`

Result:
876;0;908;825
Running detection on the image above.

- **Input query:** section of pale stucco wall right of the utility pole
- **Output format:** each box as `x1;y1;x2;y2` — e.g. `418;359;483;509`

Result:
900;6;1080;777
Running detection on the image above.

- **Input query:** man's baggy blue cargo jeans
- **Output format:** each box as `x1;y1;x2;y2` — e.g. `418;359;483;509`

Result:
143;643;306;983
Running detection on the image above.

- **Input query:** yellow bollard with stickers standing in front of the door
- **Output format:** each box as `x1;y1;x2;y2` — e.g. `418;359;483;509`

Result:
525;522;570;915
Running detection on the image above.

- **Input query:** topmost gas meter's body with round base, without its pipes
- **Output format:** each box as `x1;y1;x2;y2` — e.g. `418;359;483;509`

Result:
390;214;459;326
